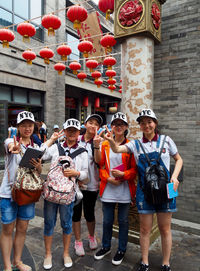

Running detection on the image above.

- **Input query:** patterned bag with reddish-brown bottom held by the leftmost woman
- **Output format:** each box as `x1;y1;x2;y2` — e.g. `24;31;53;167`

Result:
11;167;44;206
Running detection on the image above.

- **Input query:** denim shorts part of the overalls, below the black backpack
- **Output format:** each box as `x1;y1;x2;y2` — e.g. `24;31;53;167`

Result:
136;185;177;214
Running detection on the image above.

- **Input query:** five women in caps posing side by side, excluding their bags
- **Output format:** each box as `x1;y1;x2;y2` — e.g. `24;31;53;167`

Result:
0;109;183;271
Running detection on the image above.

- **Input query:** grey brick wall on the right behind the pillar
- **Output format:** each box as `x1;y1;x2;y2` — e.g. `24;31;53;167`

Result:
153;0;200;223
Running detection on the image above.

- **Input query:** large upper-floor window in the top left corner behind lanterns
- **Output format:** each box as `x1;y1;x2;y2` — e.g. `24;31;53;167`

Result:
0;0;44;41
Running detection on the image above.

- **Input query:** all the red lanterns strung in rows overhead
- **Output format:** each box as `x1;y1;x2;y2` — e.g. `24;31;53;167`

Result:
0;0;121;91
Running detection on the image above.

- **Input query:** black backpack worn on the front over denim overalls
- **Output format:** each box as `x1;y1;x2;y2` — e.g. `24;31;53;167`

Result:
136;136;169;205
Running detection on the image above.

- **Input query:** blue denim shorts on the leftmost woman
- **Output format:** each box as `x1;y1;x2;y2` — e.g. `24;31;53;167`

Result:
0;198;35;224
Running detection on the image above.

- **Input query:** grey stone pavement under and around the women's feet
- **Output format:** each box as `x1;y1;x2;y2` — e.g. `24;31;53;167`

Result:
0;199;200;271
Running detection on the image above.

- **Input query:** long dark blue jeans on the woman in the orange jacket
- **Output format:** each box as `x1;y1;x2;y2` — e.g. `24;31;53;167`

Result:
102;202;130;252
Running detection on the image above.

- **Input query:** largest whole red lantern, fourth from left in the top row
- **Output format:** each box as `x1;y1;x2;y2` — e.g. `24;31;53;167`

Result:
67;5;88;29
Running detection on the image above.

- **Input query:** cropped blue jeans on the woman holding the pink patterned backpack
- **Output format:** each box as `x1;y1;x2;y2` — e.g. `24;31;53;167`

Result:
44;200;74;236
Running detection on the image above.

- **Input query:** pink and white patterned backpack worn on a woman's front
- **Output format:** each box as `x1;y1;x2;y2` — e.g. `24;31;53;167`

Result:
42;156;76;205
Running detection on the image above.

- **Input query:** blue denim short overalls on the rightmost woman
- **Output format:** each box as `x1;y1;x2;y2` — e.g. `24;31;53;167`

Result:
135;136;177;214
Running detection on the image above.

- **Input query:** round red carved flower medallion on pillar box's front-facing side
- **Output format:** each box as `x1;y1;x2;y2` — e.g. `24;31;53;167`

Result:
119;0;143;27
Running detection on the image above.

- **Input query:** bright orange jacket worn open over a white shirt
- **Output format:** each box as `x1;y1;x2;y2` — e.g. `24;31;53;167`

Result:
99;139;137;199
